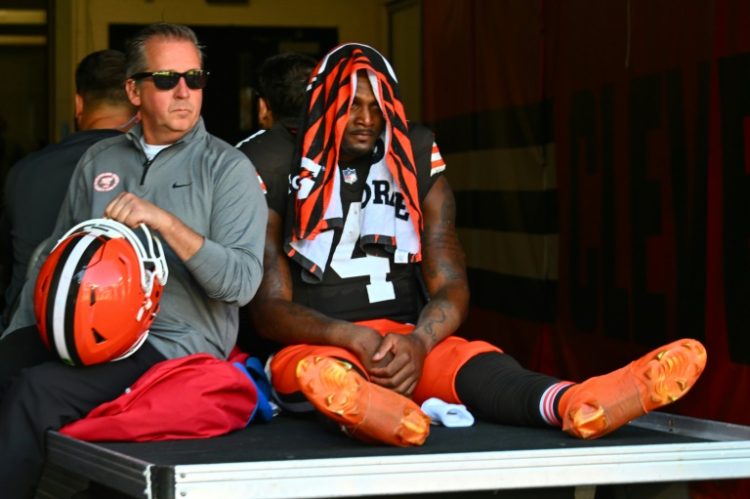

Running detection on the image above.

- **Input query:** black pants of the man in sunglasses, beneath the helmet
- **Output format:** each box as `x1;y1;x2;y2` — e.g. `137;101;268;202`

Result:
0;327;164;499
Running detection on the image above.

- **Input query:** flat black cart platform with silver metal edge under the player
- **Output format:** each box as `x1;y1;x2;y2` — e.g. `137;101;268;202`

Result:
40;413;750;499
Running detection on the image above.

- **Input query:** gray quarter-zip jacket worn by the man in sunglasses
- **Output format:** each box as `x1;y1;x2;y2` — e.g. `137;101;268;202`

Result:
4;119;268;358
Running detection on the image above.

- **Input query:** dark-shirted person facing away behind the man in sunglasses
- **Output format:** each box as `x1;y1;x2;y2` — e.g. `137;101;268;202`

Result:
0;50;137;326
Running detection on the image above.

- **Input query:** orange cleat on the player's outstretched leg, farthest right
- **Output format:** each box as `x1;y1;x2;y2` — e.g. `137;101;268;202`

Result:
559;339;706;439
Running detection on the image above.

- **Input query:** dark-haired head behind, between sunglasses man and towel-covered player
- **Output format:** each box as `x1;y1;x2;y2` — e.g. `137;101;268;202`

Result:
258;53;317;129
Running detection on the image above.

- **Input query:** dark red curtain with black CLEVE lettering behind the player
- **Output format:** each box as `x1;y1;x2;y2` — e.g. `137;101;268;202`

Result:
422;0;750;495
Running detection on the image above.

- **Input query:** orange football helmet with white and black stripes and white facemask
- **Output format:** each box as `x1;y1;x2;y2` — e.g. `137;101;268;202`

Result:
34;218;169;365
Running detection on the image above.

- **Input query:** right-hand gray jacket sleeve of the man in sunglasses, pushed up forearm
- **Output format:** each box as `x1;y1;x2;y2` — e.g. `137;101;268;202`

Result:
185;153;268;306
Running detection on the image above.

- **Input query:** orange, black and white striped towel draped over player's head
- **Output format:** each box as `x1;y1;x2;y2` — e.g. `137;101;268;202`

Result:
285;43;422;279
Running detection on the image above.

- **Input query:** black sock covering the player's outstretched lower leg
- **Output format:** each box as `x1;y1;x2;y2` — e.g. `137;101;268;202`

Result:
456;352;564;426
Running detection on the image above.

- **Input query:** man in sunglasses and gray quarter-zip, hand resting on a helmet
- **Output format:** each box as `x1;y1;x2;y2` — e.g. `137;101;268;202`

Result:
0;24;267;498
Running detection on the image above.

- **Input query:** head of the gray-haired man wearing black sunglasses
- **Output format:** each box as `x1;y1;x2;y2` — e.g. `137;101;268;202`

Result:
125;23;208;145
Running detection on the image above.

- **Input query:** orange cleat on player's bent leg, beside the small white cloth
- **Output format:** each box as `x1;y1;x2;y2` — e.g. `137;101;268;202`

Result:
296;356;430;447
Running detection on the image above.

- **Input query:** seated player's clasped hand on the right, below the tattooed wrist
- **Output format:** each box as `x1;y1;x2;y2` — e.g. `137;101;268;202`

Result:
369;333;428;397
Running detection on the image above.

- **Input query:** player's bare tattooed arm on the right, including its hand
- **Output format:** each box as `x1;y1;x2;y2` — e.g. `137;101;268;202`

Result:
370;177;469;395
